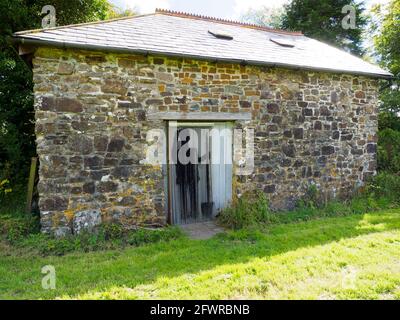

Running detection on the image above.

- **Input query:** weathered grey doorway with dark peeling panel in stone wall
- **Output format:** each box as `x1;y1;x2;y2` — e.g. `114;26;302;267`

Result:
168;121;232;224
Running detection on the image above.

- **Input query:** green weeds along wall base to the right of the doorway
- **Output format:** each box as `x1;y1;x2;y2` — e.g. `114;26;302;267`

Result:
218;172;400;229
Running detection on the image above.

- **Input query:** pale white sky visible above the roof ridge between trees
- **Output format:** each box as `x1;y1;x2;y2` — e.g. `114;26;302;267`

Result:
110;0;389;19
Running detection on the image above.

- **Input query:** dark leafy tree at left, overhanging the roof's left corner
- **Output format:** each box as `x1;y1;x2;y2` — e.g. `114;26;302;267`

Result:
0;0;112;192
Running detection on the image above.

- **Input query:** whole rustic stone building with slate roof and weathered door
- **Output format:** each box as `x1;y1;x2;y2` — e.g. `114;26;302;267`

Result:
14;10;391;235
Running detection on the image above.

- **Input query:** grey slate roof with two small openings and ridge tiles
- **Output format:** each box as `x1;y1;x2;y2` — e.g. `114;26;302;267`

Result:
14;10;392;77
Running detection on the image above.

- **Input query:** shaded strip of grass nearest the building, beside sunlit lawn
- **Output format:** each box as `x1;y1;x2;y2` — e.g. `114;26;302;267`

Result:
0;210;400;299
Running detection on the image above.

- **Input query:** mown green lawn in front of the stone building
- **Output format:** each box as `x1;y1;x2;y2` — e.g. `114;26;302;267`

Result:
0;210;400;299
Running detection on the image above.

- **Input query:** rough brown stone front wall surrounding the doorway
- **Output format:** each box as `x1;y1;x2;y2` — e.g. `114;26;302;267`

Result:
34;48;378;235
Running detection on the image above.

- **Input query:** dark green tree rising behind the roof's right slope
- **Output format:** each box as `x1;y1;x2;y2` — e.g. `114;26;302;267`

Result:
281;0;367;55
